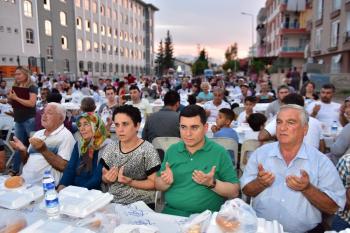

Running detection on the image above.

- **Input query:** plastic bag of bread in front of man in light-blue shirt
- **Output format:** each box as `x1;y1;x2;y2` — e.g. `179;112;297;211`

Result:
216;198;258;233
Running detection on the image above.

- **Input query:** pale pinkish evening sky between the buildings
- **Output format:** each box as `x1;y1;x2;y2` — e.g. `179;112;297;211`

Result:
145;0;265;63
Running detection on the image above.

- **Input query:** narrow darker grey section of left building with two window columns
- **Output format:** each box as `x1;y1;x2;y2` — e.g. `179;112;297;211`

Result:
37;0;77;78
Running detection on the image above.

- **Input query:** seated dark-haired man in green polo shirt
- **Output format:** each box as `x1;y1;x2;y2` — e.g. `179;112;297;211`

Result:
156;105;239;216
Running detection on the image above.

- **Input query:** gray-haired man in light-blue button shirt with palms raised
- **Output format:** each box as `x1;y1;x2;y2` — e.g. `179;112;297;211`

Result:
241;104;345;233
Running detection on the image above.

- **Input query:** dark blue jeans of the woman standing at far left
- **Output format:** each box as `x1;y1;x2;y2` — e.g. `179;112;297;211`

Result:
12;117;35;173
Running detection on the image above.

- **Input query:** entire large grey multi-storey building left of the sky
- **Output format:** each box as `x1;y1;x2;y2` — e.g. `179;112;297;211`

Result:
0;0;158;78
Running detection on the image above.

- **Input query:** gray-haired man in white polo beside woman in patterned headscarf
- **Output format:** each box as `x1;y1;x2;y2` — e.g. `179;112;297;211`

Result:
10;103;75;185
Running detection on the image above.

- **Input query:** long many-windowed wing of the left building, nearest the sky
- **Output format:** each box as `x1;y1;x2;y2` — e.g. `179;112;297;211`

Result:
74;0;158;77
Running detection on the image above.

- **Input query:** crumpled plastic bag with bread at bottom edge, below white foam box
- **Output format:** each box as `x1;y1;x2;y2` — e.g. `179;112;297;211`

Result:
77;212;121;232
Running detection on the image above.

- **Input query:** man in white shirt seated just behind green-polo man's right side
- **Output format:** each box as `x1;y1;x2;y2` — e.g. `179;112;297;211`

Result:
203;88;231;122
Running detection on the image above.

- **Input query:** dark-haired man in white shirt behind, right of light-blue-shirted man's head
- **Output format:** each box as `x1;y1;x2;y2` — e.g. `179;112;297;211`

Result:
306;84;341;127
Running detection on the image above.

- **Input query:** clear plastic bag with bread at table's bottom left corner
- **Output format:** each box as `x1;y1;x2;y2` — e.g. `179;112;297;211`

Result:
0;210;27;233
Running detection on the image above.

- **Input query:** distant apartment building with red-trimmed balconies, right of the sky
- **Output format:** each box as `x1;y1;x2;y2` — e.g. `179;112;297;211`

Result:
264;0;312;68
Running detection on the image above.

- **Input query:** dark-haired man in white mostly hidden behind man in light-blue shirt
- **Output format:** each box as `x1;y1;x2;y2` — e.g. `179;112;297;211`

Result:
258;93;325;152
